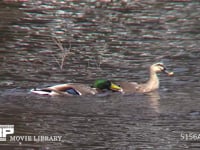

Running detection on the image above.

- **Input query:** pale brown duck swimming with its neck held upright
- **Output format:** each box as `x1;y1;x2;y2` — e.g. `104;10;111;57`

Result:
119;63;174;93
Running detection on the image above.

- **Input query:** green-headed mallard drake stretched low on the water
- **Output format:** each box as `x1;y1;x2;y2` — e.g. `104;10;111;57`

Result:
31;79;122;96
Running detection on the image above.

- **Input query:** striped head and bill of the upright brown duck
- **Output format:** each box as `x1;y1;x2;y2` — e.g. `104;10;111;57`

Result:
150;62;174;76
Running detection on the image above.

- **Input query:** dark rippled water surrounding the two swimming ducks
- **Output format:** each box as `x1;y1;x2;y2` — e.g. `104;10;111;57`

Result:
0;0;200;150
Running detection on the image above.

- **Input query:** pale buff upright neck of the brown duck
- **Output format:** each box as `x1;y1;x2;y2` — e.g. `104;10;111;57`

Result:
146;70;159;91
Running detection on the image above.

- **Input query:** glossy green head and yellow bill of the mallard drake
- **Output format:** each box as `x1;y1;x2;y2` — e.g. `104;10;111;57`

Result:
92;79;123;92
